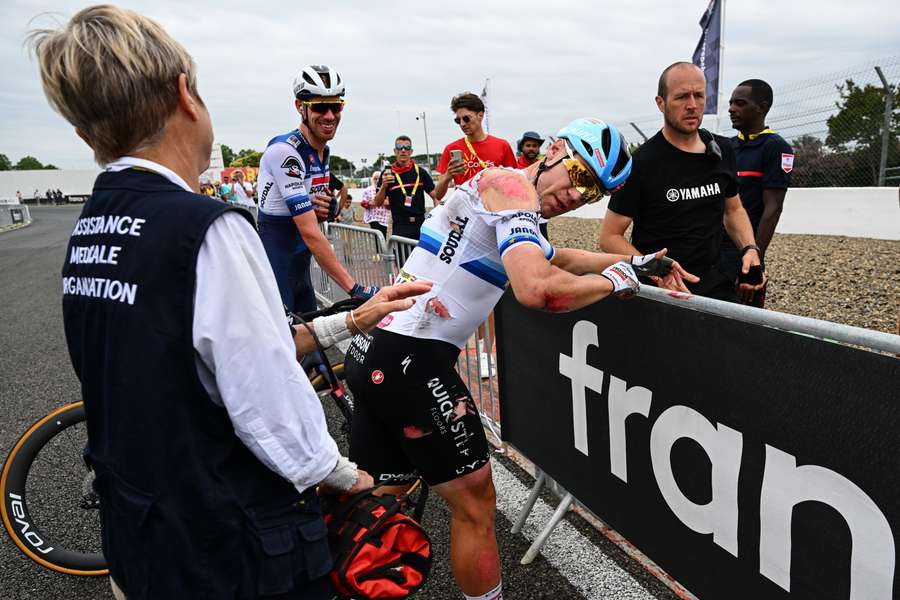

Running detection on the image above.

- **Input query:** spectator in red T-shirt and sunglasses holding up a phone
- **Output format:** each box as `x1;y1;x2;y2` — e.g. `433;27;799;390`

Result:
434;92;516;200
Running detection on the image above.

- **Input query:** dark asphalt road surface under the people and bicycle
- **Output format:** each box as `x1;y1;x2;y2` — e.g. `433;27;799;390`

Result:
0;207;675;600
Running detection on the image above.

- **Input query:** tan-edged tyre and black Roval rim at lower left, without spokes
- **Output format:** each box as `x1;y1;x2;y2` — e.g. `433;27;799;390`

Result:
0;402;109;577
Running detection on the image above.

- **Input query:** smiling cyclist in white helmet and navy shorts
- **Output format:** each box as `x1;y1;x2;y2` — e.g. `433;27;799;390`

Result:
258;65;378;312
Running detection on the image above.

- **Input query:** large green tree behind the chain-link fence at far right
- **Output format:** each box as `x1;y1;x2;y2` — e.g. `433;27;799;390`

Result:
825;79;900;185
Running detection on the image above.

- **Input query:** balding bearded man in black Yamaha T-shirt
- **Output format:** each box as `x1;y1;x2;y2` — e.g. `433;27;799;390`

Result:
600;62;763;301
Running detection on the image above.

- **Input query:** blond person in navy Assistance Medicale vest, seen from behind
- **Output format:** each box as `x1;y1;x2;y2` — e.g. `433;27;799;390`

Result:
29;6;429;600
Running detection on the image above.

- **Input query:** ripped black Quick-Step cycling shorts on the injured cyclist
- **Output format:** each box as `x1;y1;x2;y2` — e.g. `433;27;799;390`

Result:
344;329;488;485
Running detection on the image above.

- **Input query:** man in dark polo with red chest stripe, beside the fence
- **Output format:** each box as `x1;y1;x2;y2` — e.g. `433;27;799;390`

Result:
719;79;794;308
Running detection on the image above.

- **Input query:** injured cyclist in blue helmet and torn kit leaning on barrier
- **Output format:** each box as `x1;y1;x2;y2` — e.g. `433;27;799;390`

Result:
345;119;683;599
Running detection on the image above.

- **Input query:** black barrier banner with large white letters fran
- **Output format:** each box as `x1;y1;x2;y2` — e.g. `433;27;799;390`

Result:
497;294;900;600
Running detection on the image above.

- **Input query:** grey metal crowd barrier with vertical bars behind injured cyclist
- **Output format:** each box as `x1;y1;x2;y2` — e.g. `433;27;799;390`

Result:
311;223;500;445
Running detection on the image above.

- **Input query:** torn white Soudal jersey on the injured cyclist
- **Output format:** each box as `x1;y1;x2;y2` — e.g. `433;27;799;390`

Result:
379;169;553;348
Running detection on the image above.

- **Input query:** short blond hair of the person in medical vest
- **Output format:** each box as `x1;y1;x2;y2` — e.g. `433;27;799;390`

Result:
26;5;202;165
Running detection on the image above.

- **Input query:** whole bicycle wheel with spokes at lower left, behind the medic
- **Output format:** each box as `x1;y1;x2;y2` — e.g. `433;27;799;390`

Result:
0;402;109;576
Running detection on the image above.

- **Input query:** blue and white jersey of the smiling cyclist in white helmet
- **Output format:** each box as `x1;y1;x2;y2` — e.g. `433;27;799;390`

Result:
257;129;330;225
